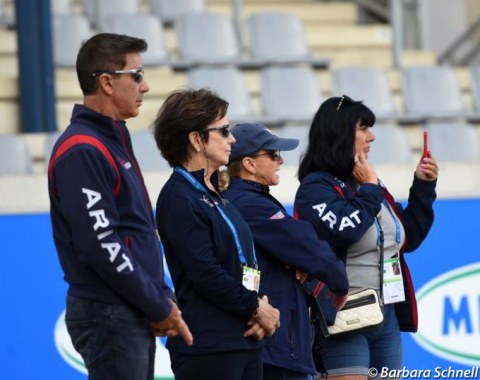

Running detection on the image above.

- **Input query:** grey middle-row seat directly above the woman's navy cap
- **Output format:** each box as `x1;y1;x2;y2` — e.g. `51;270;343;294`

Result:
260;66;322;123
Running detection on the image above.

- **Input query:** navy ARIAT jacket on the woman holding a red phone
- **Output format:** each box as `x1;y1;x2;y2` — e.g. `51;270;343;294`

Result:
295;171;436;331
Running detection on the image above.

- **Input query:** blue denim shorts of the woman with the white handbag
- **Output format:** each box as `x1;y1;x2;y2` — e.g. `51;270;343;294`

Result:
320;304;402;378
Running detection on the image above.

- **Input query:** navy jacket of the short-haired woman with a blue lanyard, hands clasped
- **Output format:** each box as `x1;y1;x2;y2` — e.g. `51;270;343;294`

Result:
156;170;262;354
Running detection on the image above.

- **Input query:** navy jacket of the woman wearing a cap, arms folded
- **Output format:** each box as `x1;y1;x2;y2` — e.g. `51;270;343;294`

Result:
225;178;348;374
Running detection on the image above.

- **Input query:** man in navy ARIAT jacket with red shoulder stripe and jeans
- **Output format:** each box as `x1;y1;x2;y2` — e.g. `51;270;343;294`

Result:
48;34;192;380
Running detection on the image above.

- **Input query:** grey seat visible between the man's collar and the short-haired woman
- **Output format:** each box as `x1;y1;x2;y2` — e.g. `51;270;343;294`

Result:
130;130;170;171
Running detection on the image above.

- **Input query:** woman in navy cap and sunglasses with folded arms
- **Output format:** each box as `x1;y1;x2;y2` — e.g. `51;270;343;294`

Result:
224;124;348;380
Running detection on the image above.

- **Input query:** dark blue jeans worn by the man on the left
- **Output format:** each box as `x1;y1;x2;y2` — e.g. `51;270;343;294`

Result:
65;296;155;380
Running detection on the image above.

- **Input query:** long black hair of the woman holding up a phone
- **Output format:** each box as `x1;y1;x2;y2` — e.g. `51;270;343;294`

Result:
298;96;375;181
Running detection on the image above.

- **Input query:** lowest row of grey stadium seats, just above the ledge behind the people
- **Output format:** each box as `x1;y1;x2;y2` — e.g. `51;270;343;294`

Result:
0;123;480;176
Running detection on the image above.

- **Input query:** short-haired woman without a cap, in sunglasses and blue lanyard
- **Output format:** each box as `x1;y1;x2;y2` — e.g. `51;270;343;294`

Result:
154;89;280;380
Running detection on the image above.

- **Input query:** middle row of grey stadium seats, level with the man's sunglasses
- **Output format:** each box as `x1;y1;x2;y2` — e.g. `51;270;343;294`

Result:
0;65;480;133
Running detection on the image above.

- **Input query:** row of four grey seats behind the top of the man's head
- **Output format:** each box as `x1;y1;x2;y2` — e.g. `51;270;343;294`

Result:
53;12;329;69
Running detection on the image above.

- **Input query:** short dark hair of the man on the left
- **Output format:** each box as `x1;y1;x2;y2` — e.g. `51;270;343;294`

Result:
76;33;148;95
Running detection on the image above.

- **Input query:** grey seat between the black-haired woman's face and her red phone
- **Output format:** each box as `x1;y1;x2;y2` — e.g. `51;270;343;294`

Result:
368;125;413;164
